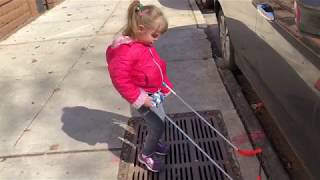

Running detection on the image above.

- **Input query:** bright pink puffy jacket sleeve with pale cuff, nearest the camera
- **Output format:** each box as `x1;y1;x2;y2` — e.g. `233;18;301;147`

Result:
108;49;147;108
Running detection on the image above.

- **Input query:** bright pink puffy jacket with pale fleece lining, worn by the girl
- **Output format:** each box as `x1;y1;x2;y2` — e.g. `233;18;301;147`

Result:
106;36;172;108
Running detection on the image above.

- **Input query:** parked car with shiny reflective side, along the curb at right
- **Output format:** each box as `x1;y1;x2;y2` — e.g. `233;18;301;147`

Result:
208;0;320;180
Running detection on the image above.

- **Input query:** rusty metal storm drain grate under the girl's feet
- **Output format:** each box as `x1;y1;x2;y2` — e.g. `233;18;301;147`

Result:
118;111;239;180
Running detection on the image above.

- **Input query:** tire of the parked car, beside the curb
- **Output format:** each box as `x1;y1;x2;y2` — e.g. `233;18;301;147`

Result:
217;9;236;70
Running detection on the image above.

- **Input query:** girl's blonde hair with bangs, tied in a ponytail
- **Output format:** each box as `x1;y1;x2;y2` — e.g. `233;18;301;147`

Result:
122;0;168;37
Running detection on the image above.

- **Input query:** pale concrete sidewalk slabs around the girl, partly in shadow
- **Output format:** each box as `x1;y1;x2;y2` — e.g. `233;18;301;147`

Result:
0;0;259;180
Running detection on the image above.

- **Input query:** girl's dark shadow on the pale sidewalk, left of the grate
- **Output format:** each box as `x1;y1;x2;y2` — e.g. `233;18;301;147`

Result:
61;106;134;156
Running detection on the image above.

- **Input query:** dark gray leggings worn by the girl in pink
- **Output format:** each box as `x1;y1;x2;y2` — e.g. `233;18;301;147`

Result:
138;104;165;155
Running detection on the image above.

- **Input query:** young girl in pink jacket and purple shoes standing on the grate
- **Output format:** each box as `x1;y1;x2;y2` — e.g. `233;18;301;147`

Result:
106;1;172;172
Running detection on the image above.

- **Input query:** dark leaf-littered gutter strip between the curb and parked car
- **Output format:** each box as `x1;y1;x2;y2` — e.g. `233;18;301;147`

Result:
219;69;290;180
